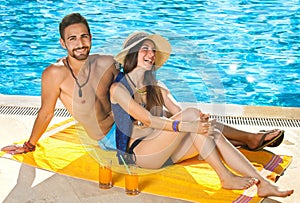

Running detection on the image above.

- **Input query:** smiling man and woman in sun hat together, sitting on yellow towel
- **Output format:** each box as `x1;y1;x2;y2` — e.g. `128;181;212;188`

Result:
2;13;293;197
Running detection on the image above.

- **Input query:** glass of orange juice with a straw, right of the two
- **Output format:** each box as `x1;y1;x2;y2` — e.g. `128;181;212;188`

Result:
125;165;140;195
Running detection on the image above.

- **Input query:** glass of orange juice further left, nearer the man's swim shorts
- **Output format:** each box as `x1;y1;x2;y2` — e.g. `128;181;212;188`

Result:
99;159;113;189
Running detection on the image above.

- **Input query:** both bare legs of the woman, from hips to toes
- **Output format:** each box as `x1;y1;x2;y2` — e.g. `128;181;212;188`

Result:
134;109;293;197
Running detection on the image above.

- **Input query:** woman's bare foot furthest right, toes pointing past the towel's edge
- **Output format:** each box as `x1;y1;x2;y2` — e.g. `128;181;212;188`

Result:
257;181;294;197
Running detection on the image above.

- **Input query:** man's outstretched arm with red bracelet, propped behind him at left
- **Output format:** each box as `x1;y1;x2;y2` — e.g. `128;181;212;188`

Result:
1;65;61;154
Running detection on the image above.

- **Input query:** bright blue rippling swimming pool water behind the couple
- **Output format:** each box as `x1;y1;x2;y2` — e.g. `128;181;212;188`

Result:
0;0;300;107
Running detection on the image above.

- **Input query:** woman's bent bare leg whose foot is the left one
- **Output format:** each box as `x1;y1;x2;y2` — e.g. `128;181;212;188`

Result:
134;109;255;189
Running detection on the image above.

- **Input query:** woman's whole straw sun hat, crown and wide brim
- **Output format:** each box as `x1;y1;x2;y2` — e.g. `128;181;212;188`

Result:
116;32;171;70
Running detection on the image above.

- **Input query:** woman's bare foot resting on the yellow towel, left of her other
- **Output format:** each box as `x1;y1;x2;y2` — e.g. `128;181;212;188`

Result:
221;175;259;190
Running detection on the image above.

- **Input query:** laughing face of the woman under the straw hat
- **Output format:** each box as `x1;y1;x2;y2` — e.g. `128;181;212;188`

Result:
137;40;156;70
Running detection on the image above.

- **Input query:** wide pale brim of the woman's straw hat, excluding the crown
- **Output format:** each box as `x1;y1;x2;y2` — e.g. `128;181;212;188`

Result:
115;34;172;70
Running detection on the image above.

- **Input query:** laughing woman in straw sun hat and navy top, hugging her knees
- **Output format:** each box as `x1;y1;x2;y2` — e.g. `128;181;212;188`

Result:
110;32;293;197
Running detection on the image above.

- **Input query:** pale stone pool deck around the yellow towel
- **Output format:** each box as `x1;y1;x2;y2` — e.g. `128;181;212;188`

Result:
0;95;300;203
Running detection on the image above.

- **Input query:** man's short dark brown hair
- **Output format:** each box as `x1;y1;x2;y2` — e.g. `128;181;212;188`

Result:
59;13;91;40
